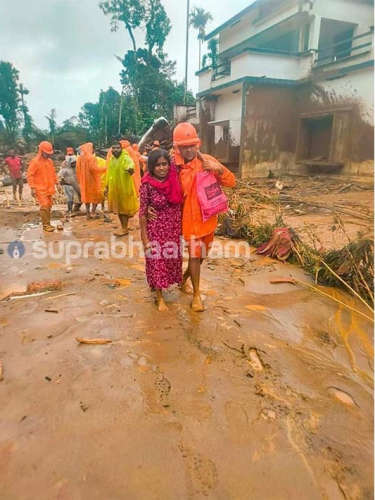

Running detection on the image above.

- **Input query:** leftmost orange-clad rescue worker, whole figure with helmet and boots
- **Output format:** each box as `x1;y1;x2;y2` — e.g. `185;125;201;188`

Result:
27;141;58;232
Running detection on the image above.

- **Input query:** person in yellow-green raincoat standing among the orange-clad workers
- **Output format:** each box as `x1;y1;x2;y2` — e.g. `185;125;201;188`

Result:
105;142;139;236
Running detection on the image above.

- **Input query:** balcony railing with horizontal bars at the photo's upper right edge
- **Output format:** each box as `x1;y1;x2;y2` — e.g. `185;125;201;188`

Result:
315;31;374;66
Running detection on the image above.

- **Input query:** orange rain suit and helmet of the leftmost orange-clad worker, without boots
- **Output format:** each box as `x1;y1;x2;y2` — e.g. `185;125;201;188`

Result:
27;141;57;208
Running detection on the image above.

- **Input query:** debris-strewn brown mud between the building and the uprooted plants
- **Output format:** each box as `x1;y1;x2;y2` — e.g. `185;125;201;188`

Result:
230;175;374;250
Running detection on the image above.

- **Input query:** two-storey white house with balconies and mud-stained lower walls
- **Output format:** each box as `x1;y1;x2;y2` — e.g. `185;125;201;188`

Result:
197;0;373;176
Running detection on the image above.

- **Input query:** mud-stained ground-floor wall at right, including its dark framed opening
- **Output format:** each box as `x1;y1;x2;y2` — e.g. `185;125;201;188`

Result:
240;70;374;177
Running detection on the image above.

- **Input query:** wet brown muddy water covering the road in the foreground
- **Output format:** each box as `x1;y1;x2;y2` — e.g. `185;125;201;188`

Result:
0;212;373;500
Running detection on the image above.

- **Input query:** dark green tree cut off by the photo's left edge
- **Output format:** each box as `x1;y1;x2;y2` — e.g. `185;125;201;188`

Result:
0;61;19;142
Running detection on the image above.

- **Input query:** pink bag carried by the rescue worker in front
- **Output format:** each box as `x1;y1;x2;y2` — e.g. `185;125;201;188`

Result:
196;171;228;222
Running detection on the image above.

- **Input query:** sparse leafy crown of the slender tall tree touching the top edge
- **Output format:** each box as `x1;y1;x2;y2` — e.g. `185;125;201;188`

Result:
99;0;146;52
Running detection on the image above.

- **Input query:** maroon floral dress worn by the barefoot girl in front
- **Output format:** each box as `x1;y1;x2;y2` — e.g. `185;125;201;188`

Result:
139;183;182;289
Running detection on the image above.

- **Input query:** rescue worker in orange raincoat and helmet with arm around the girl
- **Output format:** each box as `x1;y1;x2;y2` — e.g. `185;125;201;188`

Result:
173;123;236;312
